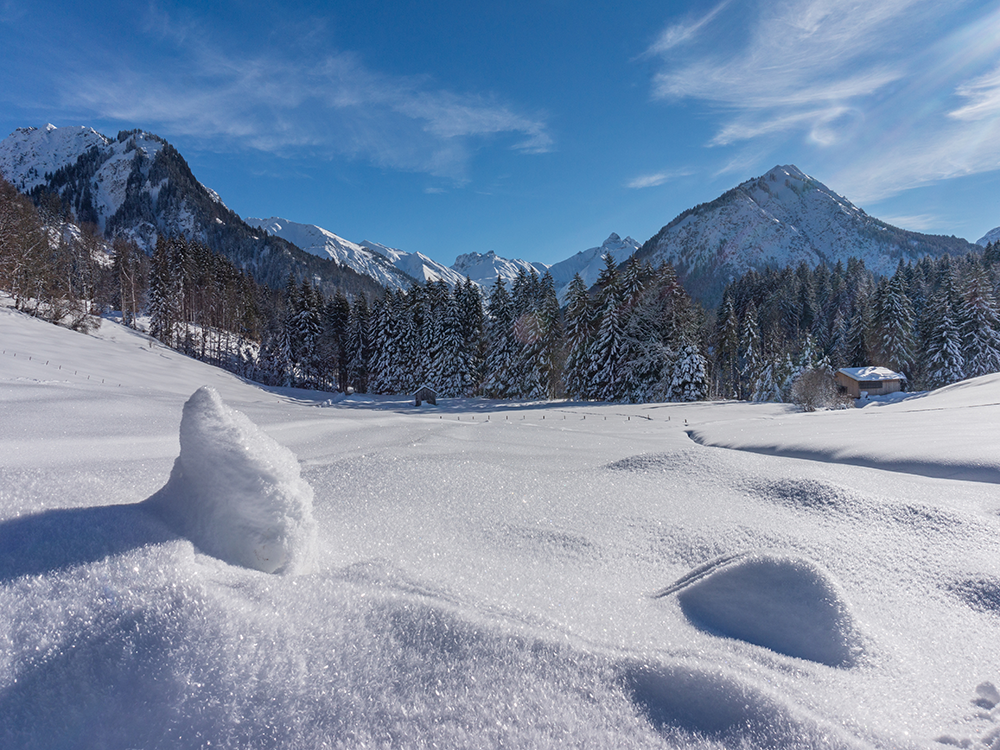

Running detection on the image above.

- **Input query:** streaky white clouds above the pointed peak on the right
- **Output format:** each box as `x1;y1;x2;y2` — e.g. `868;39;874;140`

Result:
650;0;1000;200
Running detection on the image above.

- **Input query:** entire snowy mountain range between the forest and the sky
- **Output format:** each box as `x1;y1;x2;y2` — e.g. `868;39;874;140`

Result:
0;125;984;305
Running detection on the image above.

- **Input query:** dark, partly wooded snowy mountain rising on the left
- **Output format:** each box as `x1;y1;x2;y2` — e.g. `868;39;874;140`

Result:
0;125;380;295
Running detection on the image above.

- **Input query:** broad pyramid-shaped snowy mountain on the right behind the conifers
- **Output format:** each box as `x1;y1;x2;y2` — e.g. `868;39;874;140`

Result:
636;166;975;305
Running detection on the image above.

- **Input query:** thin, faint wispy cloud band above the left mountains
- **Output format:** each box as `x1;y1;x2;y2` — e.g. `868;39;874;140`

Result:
63;9;553;182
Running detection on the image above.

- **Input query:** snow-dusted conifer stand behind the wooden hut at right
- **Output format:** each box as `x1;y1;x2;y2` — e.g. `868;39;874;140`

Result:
712;243;1000;401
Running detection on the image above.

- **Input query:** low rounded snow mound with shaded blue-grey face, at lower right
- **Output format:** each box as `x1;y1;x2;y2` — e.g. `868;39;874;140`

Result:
657;553;863;667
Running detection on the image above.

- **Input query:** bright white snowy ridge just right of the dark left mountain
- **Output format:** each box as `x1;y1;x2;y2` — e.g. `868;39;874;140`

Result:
247;216;414;289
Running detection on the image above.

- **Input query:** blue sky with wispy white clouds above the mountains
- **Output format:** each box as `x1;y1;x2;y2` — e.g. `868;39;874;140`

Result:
0;0;1000;264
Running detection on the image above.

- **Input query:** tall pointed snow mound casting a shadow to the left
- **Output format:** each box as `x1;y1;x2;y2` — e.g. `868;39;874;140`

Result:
146;387;316;573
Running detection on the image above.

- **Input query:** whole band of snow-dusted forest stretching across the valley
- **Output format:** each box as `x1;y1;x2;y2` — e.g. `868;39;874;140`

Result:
0;174;1000;405
